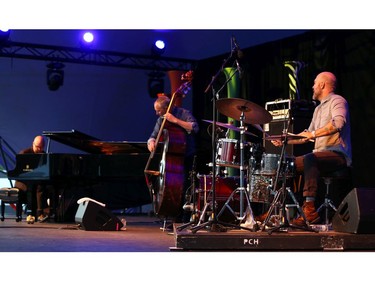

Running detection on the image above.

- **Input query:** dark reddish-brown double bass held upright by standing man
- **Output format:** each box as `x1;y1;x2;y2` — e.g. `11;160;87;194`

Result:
144;71;193;217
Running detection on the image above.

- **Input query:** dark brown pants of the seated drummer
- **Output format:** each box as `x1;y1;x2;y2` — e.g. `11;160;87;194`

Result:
295;151;346;197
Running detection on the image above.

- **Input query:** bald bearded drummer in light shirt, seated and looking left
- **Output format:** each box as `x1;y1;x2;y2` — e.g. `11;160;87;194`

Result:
271;72;352;226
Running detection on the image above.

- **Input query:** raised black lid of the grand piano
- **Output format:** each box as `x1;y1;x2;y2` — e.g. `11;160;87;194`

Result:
43;129;149;154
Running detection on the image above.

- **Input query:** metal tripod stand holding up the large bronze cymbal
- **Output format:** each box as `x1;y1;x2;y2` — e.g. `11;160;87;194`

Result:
218;111;256;230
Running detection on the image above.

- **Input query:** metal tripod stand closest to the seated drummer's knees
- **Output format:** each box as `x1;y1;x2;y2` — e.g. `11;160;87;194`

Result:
260;120;316;234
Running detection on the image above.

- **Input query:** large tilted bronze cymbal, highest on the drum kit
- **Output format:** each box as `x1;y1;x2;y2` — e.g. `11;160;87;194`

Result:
216;98;272;124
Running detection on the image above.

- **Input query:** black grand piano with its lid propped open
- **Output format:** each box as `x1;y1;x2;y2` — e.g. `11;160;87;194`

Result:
8;130;159;221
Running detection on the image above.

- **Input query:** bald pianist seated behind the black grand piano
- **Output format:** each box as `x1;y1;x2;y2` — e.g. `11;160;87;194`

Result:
15;136;55;222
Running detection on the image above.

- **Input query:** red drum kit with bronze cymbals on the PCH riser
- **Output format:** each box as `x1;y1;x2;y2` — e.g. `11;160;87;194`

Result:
180;98;308;232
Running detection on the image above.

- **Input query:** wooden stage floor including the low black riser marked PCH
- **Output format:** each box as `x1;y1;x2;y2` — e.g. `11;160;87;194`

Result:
0;203;375;252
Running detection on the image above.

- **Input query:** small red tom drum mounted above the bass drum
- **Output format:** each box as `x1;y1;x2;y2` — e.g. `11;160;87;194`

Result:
217;139;240;165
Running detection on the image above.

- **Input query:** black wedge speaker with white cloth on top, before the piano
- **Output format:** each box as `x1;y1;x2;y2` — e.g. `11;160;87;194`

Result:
75;197;123;231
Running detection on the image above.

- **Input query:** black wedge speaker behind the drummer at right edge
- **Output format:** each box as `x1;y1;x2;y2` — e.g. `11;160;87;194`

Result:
332;188;375;233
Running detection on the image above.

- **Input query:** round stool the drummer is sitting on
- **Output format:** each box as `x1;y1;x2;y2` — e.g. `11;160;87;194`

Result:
317;167;352;230
